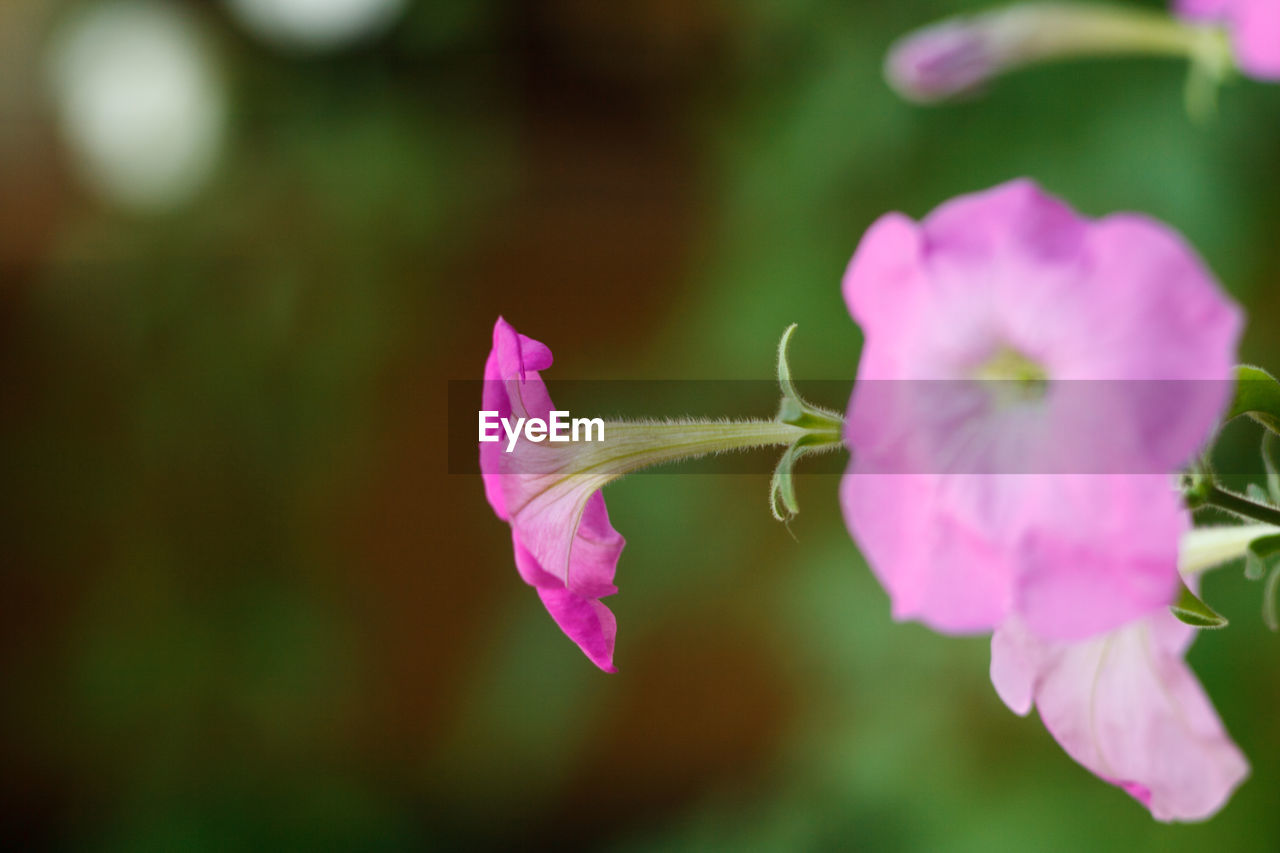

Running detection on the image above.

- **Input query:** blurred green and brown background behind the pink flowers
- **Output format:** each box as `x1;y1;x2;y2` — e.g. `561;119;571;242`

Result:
0;0;1280;853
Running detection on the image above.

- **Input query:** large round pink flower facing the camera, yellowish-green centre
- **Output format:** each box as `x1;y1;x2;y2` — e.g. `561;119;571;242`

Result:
841;181;1240;639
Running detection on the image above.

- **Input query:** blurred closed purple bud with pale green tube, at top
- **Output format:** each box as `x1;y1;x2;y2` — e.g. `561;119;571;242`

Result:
884;0;1233;108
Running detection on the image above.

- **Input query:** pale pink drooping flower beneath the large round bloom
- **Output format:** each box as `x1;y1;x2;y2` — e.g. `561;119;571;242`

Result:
991;607;1249;821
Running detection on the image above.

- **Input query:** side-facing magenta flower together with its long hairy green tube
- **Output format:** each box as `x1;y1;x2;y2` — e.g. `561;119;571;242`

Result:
479;318;841;672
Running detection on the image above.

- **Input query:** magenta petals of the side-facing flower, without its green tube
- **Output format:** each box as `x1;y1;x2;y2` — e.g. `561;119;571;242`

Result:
480;318;625;672
